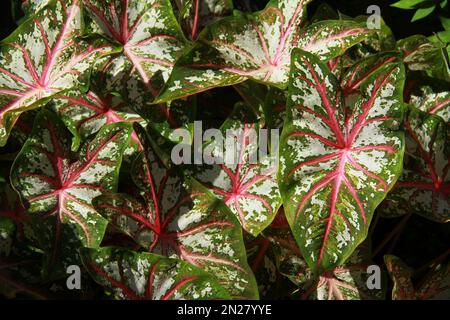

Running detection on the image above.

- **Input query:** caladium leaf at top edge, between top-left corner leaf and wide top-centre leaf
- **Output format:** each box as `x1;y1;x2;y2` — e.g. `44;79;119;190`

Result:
84;0;186;107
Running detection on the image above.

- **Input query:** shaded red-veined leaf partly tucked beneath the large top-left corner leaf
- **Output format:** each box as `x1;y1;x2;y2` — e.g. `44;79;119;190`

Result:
53;90;145;150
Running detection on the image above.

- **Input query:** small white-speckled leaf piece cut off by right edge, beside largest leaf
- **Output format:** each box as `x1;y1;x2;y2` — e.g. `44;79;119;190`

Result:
410;86;450;123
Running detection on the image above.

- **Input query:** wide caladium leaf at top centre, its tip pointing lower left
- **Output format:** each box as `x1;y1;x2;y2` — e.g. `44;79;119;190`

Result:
155;0;370;103
